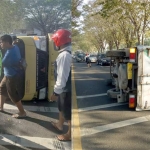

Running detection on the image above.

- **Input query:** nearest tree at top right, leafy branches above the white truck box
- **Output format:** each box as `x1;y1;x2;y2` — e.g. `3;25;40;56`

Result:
95;0;150;44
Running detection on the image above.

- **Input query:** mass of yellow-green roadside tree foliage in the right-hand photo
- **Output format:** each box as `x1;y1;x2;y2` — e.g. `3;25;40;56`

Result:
73;0;150;51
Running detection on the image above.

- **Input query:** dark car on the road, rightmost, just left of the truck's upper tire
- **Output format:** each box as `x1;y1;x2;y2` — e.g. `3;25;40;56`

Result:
97;54;113;66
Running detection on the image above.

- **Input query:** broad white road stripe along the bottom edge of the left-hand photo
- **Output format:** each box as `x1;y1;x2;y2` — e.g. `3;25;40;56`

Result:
0;134;71;150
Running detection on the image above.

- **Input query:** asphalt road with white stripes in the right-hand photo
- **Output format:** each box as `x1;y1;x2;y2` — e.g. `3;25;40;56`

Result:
73;63;150;150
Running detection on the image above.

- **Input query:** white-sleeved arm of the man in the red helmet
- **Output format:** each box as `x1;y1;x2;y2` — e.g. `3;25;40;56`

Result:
54;54;72;94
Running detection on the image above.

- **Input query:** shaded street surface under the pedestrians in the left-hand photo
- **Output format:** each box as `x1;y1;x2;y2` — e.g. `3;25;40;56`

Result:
0;100;71;150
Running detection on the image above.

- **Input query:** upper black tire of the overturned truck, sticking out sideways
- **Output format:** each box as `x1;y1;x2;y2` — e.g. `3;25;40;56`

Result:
106;50;126;57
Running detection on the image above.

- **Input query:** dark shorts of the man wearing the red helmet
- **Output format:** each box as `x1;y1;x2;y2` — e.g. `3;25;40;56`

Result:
58;92;71;120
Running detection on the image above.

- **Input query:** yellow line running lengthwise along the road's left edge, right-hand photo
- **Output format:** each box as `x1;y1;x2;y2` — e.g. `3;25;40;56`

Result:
72;66;82;150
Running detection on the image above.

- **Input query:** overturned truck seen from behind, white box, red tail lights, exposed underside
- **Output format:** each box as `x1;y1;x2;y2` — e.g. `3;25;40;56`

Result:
106;46;150;111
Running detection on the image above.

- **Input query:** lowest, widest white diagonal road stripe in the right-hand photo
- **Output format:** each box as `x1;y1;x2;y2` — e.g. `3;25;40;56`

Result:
81;115;150;136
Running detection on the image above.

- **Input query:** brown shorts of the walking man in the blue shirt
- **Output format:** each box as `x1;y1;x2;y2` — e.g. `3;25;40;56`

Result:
0;75;25;103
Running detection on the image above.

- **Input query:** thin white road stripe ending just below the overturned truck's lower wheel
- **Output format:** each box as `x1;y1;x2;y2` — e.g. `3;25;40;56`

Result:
78;103;128;112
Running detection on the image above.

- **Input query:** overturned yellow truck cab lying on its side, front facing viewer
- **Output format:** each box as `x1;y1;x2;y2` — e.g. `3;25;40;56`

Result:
0;34;58;101
